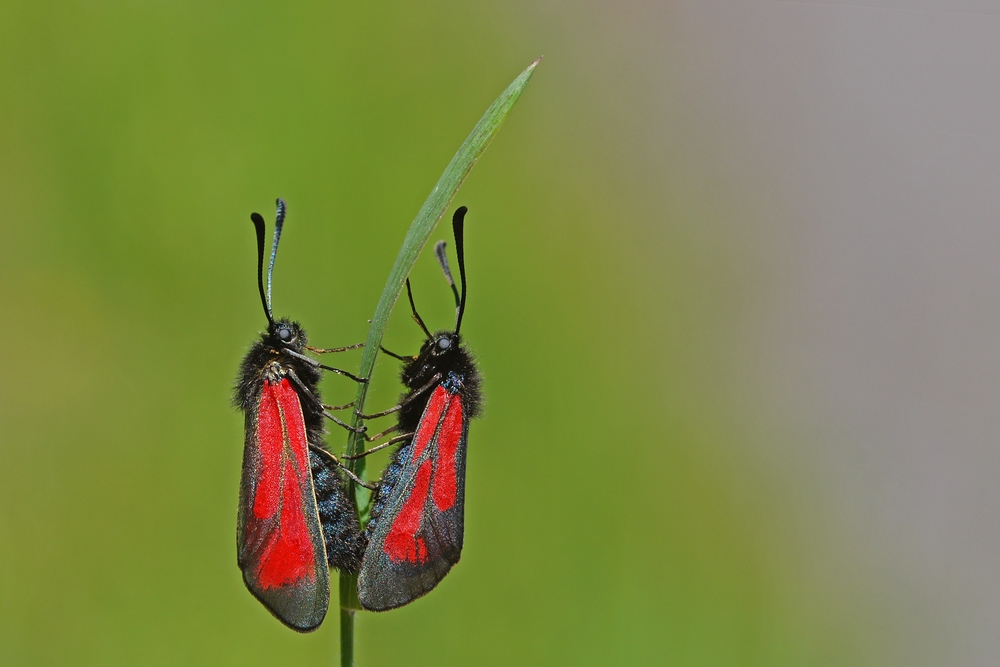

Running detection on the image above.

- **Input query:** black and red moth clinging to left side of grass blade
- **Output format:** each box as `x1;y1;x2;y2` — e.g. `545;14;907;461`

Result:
233;199;364;632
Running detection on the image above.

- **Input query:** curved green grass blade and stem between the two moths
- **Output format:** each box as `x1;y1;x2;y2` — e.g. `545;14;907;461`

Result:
340;58;542;667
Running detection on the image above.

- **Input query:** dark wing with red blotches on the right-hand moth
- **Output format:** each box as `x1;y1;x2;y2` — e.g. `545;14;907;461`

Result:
358;387;469;611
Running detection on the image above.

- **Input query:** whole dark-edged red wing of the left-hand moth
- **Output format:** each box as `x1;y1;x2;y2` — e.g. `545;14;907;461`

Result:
236;379;330;632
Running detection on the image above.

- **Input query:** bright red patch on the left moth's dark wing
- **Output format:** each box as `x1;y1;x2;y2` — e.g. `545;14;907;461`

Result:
249;379;316;589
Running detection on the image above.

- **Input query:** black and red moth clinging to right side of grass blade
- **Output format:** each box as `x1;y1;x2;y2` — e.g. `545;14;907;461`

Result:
358;206;481;611
